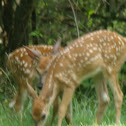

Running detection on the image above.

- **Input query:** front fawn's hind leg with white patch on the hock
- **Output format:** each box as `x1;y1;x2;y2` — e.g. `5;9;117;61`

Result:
94;73;110;124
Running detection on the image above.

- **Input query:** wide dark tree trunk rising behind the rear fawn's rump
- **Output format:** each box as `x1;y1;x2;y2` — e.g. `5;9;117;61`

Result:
7;0;36;52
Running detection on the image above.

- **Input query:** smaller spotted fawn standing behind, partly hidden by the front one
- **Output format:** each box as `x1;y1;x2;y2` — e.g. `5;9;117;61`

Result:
8;45;56;112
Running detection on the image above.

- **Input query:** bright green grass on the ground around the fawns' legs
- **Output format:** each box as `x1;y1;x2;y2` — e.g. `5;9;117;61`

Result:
0;97;126;126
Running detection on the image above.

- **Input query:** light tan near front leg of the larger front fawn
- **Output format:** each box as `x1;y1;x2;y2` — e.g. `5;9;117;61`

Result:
58;87;75;126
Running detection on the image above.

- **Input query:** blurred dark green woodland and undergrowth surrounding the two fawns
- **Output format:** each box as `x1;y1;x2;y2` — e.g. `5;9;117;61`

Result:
0;0;126;126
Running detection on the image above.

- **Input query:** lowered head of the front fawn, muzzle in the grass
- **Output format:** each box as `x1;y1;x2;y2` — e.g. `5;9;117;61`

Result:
27;84;49;126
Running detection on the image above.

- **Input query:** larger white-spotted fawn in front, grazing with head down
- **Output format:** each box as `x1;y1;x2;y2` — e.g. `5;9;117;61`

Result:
27;30;126;126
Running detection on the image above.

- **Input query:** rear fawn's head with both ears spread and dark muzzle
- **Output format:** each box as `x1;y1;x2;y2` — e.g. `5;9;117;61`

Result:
24;39;62;89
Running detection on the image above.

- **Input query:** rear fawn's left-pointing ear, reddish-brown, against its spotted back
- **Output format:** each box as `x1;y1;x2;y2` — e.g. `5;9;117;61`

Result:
24;46;41;61
